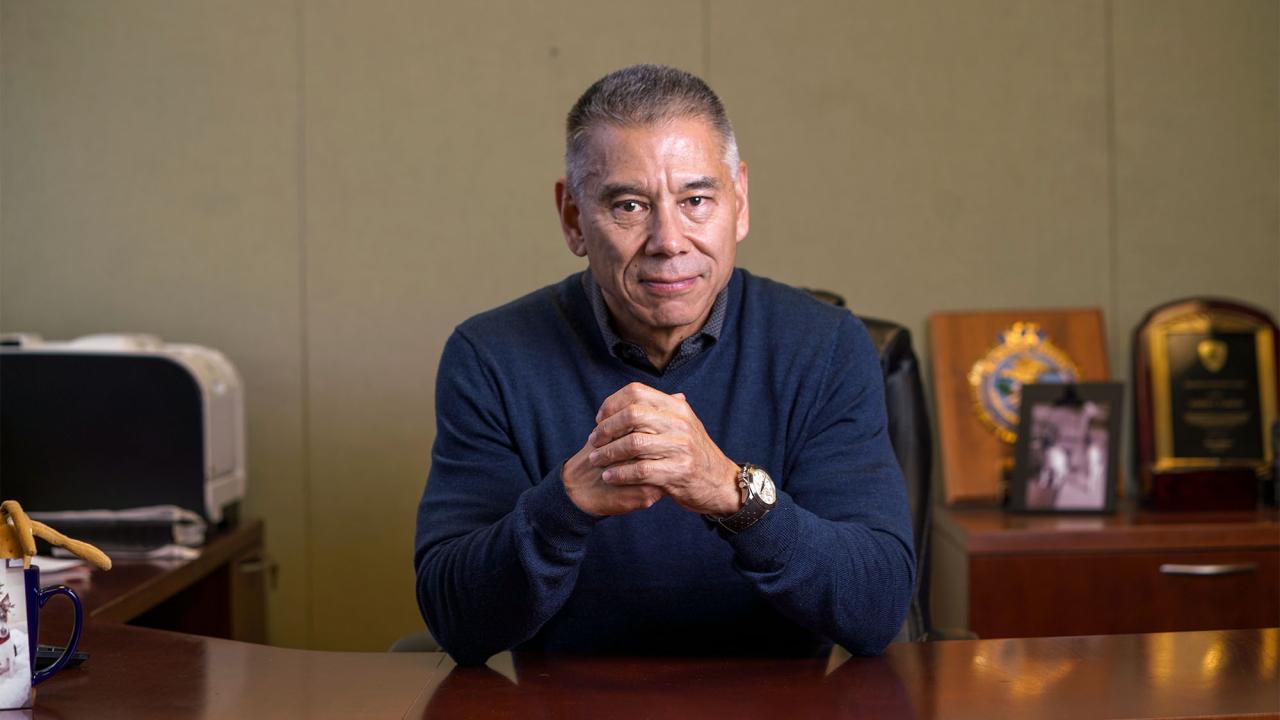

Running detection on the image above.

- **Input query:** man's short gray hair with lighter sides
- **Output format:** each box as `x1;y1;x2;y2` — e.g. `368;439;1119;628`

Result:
564;65;739;200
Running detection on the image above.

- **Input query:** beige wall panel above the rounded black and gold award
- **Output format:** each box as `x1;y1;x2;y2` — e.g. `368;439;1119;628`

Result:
1112;0;1280;361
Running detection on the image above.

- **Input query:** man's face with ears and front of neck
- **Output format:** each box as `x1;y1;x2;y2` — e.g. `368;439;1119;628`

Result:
556;119;750;345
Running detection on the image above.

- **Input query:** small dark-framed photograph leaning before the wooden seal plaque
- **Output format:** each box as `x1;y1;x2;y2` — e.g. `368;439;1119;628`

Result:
1009;383;1124;512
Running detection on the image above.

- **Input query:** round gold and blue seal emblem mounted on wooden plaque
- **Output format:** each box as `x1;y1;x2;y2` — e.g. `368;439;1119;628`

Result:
969;323;1080;443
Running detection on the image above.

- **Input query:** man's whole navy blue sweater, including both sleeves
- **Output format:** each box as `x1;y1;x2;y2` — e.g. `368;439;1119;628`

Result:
413;270;915;664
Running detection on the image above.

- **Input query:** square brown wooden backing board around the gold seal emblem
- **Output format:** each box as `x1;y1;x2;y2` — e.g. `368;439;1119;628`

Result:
929;307;1111;505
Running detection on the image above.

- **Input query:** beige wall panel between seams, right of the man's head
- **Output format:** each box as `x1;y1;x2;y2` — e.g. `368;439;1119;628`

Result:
709;0;1110;363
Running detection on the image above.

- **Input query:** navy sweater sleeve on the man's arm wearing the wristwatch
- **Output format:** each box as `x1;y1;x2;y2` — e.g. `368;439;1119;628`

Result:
728;315;915;655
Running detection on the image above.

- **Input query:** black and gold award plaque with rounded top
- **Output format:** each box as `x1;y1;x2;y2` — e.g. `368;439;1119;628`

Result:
1133;299;1277;510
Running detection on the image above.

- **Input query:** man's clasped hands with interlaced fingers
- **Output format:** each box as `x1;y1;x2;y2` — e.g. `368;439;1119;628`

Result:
561;383;741;515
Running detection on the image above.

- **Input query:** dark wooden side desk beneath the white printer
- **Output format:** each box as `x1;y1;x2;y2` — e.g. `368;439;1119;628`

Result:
40;520;266;644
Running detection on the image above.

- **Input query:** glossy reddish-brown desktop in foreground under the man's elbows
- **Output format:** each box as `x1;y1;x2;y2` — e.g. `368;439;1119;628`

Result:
36;621;1280;720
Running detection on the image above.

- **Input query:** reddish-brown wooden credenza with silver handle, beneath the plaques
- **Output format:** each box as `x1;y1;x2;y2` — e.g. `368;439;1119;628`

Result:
932;506;1280;638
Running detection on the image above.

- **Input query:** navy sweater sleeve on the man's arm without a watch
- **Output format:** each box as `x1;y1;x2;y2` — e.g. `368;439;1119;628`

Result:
413;332;598;665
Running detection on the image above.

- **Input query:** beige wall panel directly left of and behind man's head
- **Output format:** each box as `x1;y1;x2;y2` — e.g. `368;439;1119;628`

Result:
303;0;703;650
